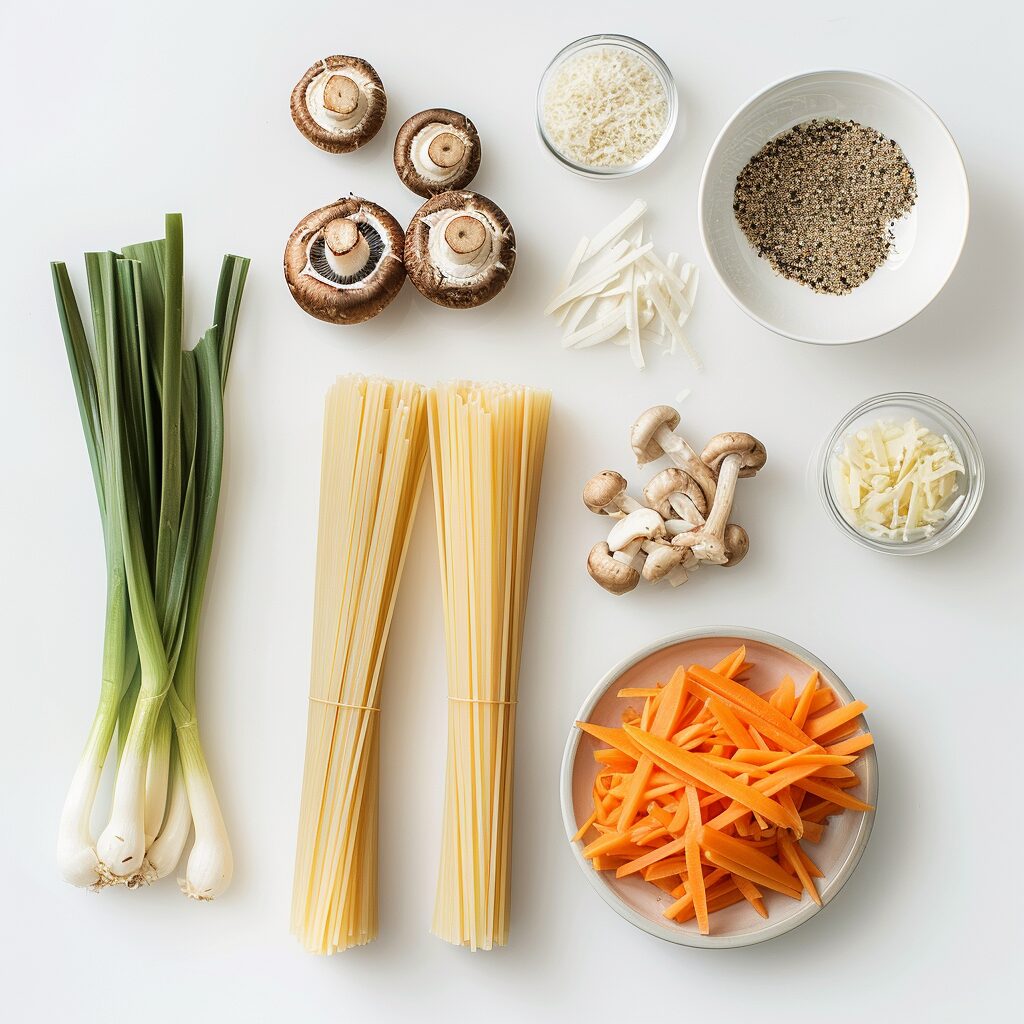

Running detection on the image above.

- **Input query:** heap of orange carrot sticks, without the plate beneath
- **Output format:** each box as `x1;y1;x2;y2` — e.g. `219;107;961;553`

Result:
574;648;872;934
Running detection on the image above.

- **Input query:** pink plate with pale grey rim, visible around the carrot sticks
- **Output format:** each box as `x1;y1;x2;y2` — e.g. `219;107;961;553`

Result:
561;626;879;949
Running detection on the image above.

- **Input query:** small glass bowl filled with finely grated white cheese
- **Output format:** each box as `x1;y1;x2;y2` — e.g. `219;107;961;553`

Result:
538;36;676;176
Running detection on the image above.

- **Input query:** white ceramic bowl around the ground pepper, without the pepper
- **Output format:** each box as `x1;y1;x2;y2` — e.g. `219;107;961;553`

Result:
697;70;970;345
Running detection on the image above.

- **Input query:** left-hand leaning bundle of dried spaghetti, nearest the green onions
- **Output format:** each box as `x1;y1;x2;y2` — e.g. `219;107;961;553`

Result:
292;376;427;953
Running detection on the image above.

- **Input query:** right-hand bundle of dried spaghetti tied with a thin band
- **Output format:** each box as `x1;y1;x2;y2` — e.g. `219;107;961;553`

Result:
430;381;551;949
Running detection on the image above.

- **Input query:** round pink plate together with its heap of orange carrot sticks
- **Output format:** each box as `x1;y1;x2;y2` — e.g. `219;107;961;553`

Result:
561;627;878;948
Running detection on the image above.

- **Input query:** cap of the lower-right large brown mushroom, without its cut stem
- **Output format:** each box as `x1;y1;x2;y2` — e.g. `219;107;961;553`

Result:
406;191;515;309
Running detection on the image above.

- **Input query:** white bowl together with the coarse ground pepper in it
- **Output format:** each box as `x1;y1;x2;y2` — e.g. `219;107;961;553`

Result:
697;70;970;345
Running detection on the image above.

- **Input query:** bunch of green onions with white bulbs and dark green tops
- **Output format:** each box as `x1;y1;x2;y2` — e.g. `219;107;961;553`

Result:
52;215;249;899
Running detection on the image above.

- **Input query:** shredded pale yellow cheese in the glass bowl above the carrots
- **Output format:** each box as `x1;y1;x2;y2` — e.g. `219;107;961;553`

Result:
831;419;964;542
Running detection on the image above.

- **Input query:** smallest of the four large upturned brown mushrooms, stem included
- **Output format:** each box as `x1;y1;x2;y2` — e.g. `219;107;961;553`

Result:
394;106;480;197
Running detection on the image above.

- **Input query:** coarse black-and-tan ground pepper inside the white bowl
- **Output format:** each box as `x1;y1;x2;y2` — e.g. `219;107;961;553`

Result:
732;120;918;295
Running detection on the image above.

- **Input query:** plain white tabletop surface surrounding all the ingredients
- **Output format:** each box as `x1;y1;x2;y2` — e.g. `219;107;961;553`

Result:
0;0;1024;1022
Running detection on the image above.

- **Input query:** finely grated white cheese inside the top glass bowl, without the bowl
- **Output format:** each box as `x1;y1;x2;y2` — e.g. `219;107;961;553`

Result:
543;46;669;167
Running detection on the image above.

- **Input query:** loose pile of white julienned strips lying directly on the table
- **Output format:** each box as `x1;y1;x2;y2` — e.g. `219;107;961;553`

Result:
544;200;701;370
